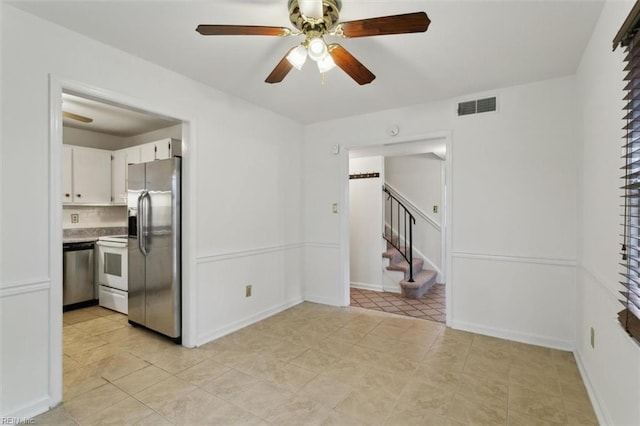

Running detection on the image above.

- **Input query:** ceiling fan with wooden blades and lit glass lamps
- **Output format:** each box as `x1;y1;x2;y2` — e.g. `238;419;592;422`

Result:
196;0;431;85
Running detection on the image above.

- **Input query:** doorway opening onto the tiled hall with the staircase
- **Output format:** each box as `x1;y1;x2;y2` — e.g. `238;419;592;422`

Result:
341;133;451;323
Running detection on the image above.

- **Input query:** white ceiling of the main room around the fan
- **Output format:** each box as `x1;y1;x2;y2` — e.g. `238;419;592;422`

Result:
11;0;603;123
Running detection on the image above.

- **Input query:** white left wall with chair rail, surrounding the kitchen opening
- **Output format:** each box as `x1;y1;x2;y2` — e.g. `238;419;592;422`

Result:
0;2;303;416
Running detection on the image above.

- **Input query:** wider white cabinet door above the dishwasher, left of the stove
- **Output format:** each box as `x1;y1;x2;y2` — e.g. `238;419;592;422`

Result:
72;147;111;204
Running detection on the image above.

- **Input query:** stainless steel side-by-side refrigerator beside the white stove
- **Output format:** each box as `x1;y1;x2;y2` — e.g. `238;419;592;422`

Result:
127;157;182;342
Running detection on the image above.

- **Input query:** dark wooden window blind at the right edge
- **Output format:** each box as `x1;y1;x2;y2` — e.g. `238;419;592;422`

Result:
614;9;640;342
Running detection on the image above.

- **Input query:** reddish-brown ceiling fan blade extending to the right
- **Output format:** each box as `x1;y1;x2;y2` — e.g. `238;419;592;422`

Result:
338;12;431;38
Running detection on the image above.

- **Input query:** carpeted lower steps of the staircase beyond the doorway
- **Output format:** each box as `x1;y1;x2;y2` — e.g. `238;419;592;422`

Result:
382;241;437;299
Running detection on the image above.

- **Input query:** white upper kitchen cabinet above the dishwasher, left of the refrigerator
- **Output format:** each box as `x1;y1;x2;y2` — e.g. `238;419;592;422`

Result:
62;146;111;204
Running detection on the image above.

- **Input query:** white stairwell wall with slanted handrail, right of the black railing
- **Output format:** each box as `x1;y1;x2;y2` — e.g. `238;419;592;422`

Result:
384;153;444;276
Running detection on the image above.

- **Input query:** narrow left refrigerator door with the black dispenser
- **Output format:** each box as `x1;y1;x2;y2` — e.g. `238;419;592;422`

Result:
127;164;146;325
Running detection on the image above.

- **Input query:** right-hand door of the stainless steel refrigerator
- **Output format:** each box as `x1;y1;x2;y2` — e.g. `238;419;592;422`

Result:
146;157;181;338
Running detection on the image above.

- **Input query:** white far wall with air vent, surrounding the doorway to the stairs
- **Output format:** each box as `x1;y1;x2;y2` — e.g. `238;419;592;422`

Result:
304;77;578;348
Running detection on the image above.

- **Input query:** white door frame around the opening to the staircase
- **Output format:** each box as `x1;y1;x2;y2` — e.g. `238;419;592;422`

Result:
338;131;453;327
